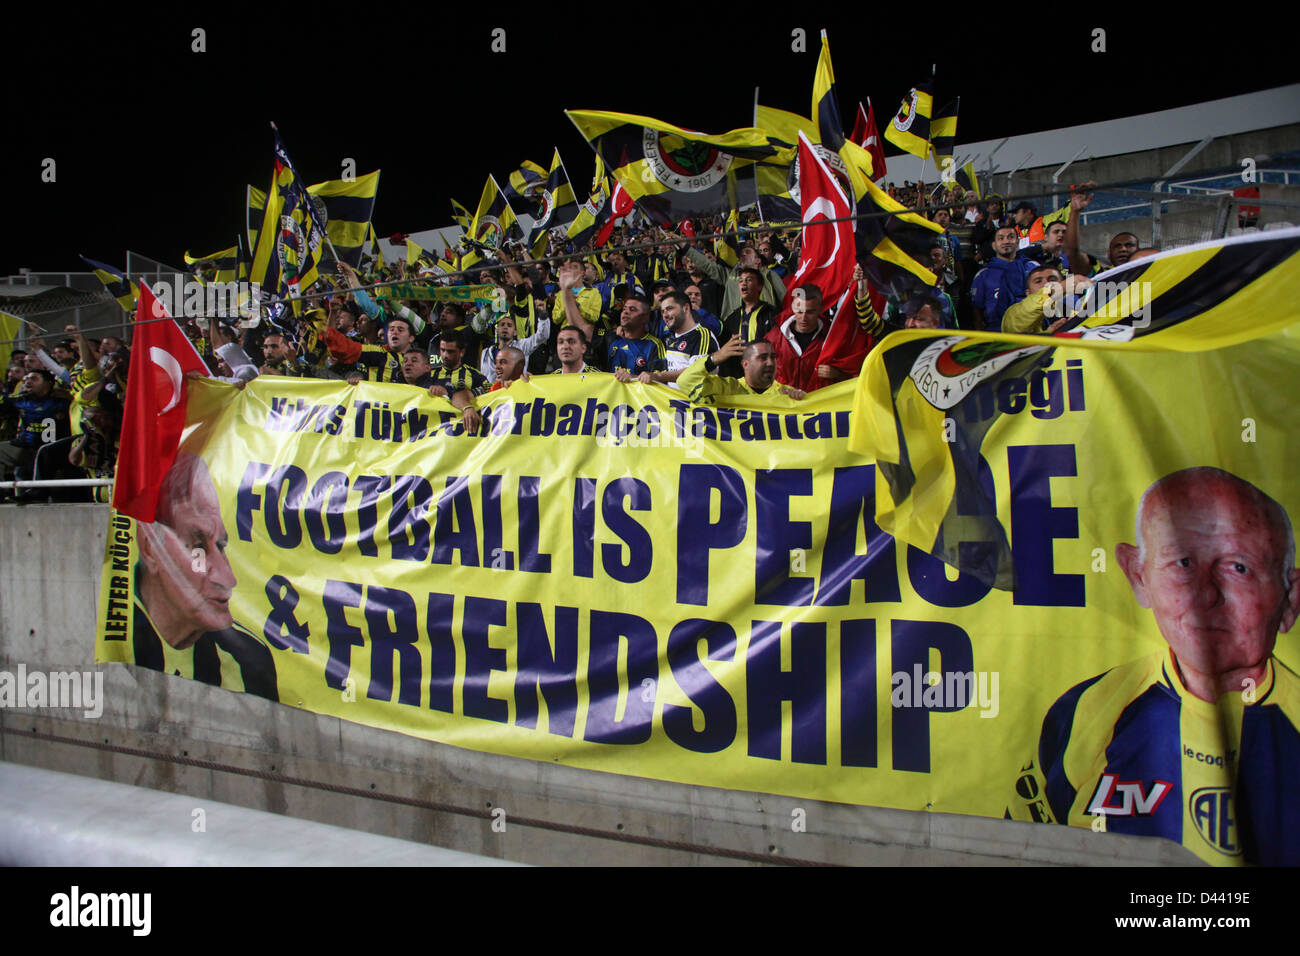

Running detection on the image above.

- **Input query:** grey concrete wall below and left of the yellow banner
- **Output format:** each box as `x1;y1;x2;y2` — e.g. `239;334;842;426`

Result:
0;505;1196;865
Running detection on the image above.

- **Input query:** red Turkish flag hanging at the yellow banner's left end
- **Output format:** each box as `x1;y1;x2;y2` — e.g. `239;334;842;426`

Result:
113;282;211;522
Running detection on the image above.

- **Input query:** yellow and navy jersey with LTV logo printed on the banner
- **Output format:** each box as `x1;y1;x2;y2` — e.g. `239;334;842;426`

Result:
1006;650;1300;866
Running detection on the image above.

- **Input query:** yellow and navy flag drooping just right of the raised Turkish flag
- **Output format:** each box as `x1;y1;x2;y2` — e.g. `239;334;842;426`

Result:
840;139;944;295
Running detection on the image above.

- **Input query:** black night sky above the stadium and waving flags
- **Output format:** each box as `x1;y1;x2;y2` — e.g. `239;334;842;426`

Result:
0;3;1300;276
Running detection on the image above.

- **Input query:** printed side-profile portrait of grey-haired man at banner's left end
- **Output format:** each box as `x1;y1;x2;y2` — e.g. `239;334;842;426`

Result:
133;451;280;700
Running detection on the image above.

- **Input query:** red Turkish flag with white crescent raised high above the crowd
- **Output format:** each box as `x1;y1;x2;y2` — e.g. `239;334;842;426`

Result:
777;133;858;324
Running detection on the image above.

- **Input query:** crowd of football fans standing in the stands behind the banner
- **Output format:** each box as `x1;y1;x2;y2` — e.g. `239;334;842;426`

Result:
0;183;1148;501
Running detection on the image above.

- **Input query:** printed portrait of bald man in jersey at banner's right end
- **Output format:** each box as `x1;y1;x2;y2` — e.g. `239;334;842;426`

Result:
1008;467;1300;865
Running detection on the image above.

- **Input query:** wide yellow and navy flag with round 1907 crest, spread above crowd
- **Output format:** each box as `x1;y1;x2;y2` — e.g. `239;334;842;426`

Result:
566;109;776;226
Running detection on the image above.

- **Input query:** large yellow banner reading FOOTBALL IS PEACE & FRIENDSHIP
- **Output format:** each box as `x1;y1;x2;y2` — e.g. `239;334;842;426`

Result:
96;326;1300;864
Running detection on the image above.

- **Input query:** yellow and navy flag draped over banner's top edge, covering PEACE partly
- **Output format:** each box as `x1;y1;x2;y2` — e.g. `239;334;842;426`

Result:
849;229;1300;589
